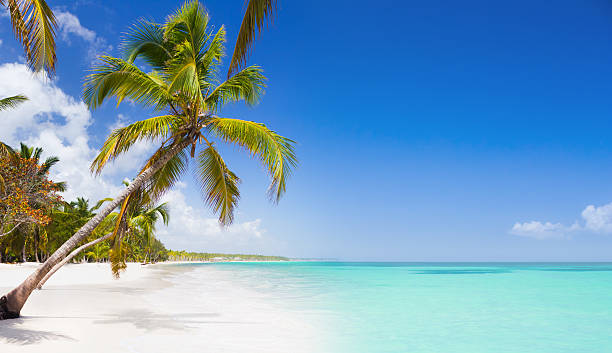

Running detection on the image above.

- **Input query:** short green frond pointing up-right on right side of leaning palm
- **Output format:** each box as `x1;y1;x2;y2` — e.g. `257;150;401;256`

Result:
206;66;266;112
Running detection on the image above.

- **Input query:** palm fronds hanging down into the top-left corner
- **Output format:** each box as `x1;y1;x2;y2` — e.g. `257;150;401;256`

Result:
0;0;57;76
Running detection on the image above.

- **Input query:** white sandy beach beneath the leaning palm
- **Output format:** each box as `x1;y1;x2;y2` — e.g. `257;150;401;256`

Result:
0;264;318;353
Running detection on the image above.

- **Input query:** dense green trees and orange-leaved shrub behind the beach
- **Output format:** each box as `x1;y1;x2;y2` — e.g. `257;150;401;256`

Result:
0;143;170;263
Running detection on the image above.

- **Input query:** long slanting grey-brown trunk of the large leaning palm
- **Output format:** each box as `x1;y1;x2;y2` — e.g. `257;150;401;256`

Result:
0;139;190;320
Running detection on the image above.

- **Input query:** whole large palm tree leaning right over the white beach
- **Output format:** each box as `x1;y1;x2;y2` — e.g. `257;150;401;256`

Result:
0;1;296;318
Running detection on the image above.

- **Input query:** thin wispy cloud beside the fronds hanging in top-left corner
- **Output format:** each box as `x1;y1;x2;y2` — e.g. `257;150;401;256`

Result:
54;10;113;60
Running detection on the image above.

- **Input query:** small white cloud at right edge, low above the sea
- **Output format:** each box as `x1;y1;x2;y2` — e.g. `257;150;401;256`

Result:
510;203;612;239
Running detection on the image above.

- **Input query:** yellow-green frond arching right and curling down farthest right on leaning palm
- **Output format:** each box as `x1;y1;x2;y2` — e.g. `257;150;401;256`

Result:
207;117;297;201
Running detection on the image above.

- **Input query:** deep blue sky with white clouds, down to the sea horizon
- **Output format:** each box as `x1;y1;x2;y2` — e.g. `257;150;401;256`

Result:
0;0;612;261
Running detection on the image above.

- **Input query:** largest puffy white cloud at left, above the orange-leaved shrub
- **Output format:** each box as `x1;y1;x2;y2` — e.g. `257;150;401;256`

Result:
0;63;120;200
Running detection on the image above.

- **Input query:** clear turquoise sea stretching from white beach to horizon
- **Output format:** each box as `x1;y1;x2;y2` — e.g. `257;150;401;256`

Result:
190;262;612;353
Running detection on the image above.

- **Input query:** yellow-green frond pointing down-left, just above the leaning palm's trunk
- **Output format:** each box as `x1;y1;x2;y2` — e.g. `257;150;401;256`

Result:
90;115;180;174
